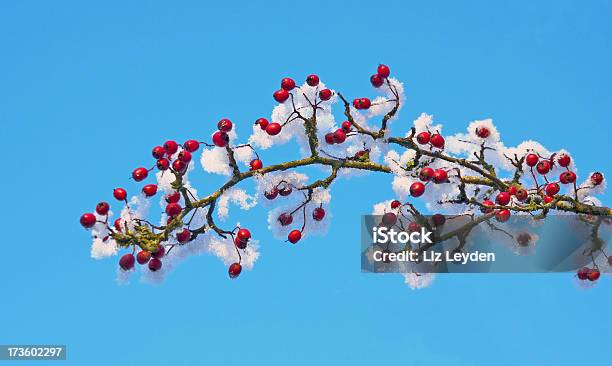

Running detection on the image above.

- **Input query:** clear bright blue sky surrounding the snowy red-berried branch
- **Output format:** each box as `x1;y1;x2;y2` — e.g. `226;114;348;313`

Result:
0;1;612;365
